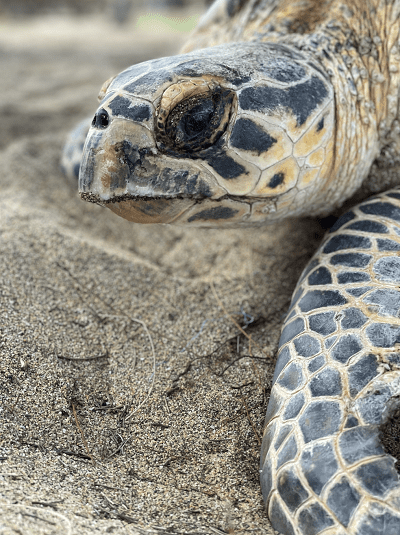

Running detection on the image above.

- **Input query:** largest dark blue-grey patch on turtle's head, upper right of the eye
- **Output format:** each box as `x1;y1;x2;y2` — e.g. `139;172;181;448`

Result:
239;76;328;126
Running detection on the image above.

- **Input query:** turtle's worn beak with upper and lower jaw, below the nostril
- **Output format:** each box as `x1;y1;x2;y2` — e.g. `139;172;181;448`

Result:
79;118;226;223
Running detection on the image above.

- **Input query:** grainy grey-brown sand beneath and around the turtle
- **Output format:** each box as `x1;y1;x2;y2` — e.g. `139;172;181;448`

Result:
0;12;322;535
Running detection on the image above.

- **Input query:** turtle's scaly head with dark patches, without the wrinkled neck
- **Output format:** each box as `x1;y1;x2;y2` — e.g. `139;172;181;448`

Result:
79;43;334;226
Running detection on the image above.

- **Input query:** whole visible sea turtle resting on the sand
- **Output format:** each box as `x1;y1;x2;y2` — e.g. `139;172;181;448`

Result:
60;0;400;535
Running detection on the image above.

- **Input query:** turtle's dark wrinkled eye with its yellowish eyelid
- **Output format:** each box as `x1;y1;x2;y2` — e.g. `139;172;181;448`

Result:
156;82;234;157
